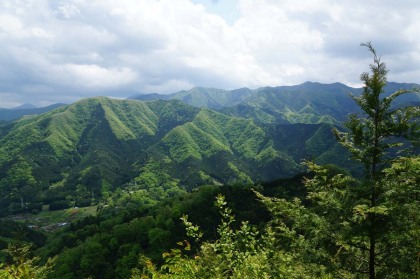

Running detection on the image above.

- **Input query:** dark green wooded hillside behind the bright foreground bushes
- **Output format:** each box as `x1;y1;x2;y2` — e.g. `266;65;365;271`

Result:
33;182;276;278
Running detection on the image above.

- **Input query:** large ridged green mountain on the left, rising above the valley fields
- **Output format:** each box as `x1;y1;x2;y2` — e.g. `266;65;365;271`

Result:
0;98;198;214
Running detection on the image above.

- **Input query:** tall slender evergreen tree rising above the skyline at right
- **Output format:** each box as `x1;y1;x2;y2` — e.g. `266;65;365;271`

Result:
335;43;420;278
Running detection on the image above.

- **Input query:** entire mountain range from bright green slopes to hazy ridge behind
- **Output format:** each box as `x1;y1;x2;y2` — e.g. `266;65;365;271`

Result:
0;83;420;215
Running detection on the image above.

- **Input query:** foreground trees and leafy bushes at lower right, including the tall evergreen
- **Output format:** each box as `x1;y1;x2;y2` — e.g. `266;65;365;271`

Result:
133;43;420;278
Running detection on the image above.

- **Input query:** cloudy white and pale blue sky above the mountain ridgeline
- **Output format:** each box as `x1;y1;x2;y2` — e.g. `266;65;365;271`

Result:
0;0;420;107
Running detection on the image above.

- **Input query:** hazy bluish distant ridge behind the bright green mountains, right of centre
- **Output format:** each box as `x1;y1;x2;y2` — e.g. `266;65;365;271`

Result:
133;82;420;124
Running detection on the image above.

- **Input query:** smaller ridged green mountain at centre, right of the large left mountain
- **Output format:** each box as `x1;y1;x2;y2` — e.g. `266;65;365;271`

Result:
149;110;300;187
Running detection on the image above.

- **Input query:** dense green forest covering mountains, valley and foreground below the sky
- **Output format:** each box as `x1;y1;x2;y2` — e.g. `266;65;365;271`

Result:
0;43;420;278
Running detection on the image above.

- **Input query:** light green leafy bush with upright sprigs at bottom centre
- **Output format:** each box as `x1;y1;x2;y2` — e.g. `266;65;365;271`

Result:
132;195;322;278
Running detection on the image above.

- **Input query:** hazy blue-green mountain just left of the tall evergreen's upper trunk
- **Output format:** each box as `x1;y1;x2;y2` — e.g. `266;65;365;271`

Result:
224;82;360;124
